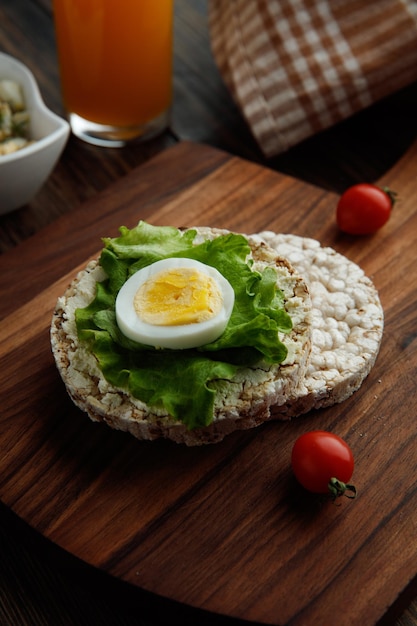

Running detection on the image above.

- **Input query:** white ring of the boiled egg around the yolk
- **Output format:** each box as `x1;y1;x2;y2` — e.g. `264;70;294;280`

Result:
116;258;235;350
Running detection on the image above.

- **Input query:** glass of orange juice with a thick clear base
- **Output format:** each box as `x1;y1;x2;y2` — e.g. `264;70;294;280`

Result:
53;0;173;147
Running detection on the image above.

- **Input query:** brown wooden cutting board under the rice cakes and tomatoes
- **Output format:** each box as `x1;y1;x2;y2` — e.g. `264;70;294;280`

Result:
0;143;417;626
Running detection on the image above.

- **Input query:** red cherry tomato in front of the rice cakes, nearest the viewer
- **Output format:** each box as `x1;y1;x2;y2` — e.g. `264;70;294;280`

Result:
291;430;356;499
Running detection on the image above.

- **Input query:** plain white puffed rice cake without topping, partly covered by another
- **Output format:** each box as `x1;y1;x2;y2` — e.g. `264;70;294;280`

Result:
255;231;384;419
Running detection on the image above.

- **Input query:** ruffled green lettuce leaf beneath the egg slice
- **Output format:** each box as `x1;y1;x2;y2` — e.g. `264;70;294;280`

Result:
76;222;292;429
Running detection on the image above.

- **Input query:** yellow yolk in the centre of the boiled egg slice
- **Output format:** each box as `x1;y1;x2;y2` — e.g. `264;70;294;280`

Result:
133;267;223;326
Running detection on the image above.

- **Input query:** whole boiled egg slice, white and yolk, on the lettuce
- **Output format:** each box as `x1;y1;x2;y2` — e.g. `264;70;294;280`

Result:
116;258;235;350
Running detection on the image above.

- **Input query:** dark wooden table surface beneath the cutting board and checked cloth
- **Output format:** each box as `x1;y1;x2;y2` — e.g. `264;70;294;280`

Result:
0;0;417;626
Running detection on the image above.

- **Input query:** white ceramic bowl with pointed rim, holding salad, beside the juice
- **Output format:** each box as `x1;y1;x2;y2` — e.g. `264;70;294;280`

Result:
0;52;70;214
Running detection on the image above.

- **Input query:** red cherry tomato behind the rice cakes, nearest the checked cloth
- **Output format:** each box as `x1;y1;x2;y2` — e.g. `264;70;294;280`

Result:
336;183;396;235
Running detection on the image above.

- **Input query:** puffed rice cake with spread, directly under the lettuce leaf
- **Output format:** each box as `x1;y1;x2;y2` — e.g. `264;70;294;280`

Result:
51;228;311;445
